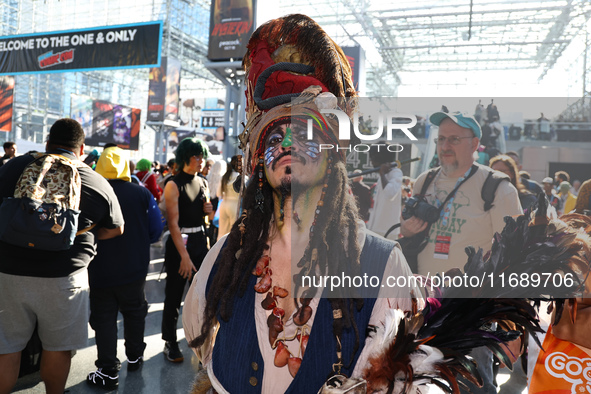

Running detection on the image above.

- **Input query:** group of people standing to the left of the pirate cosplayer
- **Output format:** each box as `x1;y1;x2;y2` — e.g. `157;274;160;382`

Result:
0;124;239;393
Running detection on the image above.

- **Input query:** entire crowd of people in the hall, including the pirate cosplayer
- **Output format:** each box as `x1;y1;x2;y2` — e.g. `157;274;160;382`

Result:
0;15;591;394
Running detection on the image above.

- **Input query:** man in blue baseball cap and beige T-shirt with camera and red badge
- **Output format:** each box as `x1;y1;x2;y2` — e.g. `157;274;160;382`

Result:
401;112;522;393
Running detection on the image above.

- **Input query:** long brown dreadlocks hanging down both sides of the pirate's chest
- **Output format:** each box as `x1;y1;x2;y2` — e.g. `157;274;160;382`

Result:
190;162;363;368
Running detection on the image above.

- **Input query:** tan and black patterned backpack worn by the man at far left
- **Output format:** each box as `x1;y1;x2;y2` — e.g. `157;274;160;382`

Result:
0;153;94;251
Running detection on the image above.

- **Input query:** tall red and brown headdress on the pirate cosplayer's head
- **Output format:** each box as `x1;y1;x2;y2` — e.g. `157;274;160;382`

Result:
239;14;357;172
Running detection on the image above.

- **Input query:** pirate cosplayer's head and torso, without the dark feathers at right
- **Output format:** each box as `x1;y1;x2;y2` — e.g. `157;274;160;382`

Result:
183;15;419;393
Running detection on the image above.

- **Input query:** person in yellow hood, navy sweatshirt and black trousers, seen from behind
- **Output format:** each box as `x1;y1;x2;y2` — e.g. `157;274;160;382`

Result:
87;147;163;389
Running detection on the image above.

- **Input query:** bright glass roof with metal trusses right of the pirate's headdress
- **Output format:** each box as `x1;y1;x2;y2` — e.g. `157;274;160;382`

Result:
276;0;591;92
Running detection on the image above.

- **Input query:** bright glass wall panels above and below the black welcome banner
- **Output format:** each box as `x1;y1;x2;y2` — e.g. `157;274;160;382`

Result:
0;0;224;139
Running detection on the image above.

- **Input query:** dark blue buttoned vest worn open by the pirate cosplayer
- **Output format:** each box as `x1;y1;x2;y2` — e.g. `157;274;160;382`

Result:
206;234;394;394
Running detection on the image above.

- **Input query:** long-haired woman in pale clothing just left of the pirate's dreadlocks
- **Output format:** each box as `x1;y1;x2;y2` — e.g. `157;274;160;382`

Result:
217;156;241;240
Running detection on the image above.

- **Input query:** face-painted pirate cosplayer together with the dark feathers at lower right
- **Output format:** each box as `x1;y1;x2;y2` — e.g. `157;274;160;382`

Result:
183;15;591;394
